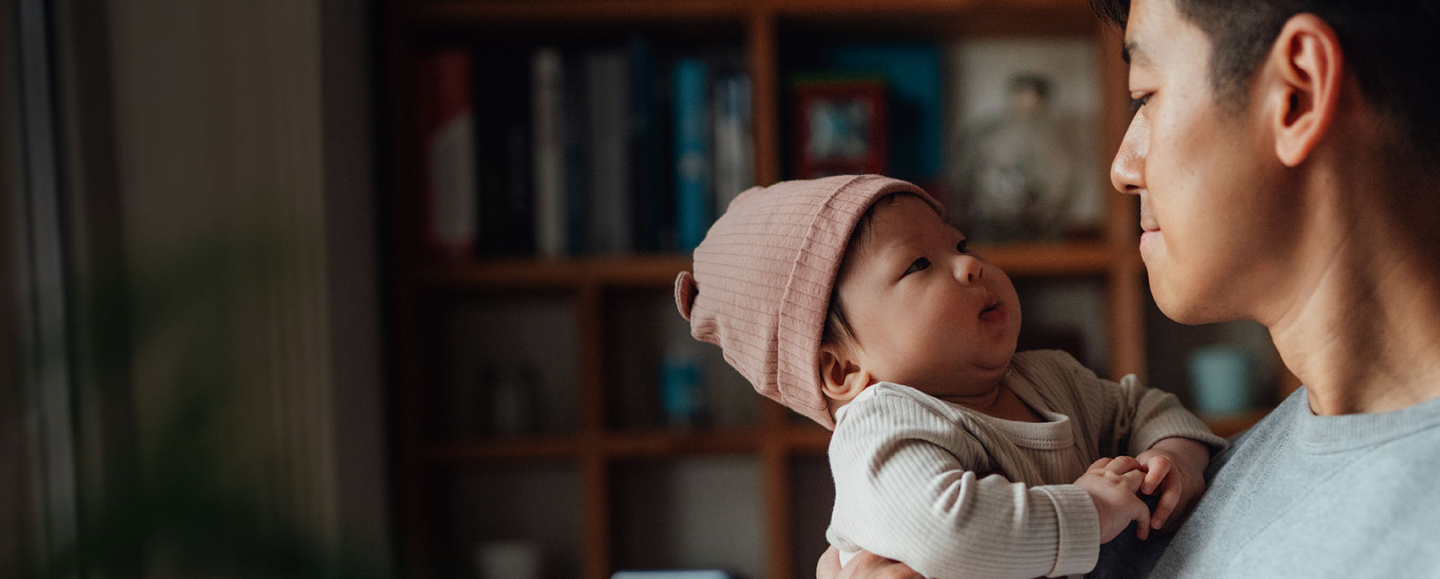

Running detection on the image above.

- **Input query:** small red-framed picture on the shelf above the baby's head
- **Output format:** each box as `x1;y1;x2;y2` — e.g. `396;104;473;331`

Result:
791;78;886;179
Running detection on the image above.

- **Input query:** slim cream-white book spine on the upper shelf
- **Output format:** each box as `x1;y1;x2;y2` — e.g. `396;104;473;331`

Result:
530;48;570;258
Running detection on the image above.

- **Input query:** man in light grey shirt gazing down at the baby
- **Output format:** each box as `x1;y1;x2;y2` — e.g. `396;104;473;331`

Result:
818;0;1440;579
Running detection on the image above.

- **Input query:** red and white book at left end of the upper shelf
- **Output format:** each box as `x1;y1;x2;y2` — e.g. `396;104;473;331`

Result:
416;49;478;258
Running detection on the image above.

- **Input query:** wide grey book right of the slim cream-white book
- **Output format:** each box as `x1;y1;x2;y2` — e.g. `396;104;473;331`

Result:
585;49;635;255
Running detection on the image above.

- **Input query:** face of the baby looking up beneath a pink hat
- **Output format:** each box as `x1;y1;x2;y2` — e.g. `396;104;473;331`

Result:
838;196;1020;398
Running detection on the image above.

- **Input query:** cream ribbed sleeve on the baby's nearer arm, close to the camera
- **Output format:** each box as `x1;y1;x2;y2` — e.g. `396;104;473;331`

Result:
828;386;1100;579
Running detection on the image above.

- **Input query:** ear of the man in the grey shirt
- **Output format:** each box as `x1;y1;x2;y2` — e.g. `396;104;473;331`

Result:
1260;14;1345;167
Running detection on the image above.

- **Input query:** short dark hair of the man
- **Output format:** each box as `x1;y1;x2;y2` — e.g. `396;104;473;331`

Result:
1090;0;1440;161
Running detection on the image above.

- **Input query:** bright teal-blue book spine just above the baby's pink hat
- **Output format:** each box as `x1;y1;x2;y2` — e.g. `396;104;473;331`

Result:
671;58;714;253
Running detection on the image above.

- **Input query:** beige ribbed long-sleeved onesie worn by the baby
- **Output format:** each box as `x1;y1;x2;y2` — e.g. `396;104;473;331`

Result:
827;351;1224;579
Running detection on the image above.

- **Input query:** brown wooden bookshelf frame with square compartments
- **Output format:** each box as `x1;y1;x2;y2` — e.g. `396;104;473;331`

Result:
380;0;1169;579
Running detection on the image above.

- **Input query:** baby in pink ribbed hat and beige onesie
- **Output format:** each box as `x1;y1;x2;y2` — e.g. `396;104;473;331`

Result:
675;176;1224;579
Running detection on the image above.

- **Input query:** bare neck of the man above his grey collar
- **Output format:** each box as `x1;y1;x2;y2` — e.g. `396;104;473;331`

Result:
1261;164;1440;415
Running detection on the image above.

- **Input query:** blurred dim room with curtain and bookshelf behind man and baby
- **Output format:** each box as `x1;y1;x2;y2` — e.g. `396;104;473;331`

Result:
0;0;1296;579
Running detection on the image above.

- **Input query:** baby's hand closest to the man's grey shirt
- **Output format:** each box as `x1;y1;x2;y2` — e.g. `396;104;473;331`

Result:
1135;438;1210;533
